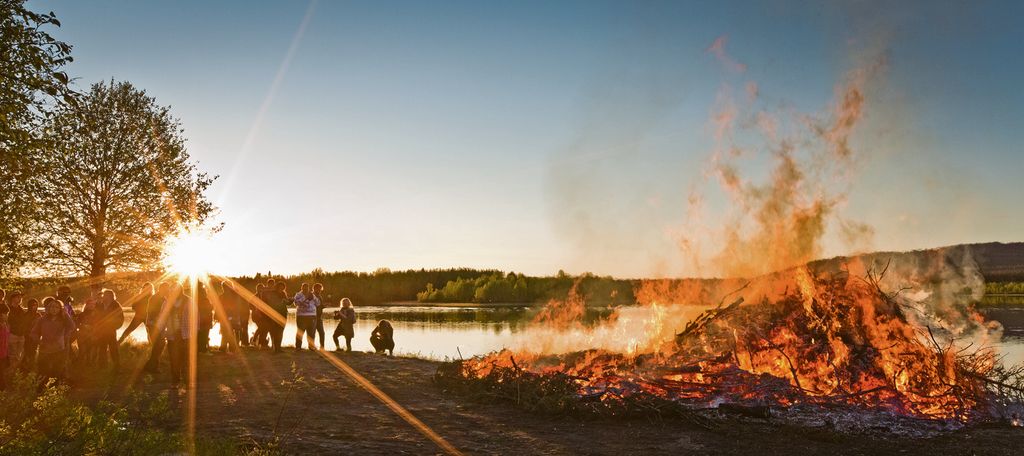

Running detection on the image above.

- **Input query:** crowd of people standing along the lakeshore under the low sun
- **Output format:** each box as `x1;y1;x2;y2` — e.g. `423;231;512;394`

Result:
0;279;394;388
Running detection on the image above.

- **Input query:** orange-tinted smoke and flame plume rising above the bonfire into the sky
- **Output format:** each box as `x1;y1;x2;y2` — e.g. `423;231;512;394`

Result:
680;47;886;277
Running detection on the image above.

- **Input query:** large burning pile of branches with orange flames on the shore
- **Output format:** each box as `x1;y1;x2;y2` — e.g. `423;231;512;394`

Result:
437;268;1024;423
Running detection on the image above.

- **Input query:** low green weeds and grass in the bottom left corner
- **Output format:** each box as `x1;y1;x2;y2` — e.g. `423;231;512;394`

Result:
0;344;287;455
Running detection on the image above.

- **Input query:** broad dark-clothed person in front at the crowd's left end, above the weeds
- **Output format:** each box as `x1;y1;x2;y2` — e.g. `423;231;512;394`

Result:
29;297;75;381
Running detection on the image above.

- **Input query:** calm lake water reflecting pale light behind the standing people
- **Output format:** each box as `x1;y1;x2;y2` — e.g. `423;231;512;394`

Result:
125;305;1024;363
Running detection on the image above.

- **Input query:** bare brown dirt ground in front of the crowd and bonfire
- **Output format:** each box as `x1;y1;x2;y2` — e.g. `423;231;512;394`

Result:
77;349;1024;456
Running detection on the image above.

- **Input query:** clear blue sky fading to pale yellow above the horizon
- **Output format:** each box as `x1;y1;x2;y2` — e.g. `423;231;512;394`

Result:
29;0;1024;277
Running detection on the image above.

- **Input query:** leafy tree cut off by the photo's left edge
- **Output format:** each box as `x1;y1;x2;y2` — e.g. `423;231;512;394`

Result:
0;0;75;277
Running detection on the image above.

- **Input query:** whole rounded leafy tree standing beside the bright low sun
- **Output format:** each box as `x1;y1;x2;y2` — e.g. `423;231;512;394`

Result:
35;81;216;277
